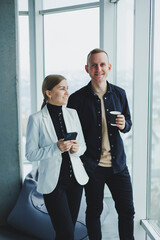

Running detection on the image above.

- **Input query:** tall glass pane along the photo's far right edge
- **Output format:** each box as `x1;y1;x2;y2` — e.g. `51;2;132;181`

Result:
149;0;160;233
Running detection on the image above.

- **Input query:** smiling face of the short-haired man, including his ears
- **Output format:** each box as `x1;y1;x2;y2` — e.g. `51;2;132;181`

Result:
85;52;111;83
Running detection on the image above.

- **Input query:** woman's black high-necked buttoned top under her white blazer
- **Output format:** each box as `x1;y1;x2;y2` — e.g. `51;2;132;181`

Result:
47;103;73;180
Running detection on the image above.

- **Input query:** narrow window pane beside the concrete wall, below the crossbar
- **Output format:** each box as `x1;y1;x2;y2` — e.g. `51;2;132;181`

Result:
19;16;32;177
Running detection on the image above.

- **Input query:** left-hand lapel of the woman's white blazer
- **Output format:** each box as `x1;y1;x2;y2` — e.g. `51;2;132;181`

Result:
42;105;58;141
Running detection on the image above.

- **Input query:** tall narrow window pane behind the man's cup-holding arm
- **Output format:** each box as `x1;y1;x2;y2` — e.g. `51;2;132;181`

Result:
116;0;134;172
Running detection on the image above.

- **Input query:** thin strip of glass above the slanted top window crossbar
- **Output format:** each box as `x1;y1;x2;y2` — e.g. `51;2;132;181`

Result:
43;0;99;10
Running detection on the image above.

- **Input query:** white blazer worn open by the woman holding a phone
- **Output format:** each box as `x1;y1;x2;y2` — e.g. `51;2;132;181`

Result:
26;106;88;194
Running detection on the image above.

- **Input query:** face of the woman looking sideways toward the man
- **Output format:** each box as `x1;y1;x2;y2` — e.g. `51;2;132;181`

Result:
46;79;69;106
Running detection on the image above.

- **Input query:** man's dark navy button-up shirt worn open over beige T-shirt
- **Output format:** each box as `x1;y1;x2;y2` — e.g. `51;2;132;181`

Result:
68;82;132;173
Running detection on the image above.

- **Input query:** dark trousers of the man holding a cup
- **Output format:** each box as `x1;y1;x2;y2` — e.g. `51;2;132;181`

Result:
85;166;135;240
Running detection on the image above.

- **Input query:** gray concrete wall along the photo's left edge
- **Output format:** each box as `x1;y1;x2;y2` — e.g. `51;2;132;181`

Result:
0;0;21;225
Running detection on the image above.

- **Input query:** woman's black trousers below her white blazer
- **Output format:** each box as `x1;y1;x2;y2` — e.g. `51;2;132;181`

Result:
43;175;83;240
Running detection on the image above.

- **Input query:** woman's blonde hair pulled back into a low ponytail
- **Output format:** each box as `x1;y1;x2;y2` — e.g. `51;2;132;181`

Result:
41;74;66;109
